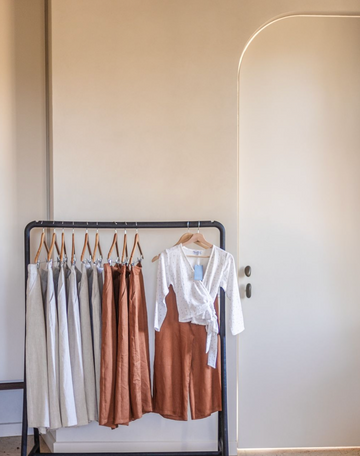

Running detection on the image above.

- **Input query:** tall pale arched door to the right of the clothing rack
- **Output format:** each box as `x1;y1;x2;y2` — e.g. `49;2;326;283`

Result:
238;17;360;448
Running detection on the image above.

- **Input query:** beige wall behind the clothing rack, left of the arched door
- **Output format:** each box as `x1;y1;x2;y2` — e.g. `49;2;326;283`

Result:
48;0;360;454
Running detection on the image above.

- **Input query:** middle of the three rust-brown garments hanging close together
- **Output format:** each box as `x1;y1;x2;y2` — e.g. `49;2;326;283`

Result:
114;265;132;425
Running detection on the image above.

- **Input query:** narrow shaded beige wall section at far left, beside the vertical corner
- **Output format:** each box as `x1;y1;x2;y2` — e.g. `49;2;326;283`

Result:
0;0;46;434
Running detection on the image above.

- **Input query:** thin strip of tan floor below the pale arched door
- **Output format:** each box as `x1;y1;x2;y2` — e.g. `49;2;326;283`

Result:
238;447;360;456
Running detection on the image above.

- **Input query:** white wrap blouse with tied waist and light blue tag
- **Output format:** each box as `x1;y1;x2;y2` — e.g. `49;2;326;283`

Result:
154;244;244;368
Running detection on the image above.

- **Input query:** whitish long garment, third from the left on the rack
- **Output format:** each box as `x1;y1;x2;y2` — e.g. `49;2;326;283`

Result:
57;264;77;427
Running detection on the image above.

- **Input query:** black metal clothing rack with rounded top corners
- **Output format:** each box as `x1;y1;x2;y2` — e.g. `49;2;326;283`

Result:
21;220;229;456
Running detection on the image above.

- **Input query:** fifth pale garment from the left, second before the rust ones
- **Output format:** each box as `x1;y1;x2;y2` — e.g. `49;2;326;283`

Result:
79;263;98;421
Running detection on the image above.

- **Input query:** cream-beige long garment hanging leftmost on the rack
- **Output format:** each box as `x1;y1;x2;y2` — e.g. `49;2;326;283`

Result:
26;264;50;430
